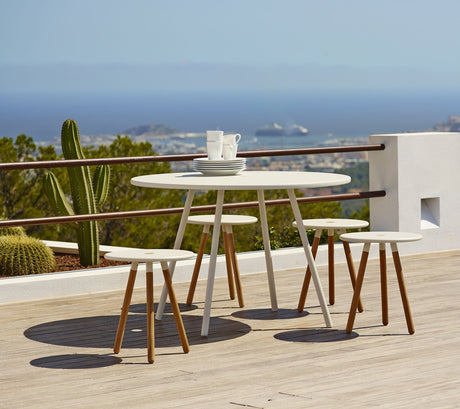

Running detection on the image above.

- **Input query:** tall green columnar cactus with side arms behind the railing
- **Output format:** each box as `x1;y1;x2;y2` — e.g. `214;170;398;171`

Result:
43;119;110;266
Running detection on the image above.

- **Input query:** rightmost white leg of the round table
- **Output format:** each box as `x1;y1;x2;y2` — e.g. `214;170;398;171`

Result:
287;189;332;328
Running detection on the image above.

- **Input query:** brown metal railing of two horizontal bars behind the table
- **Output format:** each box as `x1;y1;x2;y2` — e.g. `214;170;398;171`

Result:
0;144;386;227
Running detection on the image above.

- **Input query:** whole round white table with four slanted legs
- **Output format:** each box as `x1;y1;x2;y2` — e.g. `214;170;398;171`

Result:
131;171;351;336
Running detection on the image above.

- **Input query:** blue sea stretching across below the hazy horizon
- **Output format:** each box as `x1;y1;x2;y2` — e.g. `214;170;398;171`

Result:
0;90;460;149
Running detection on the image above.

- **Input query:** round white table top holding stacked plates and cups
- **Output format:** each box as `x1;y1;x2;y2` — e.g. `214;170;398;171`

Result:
131;171;351;190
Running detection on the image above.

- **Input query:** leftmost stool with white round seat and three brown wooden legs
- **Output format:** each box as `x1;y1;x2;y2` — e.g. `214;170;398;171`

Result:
104;249;195;363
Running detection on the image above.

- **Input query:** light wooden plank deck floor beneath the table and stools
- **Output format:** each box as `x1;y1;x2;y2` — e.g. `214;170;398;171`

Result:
0;251;460;409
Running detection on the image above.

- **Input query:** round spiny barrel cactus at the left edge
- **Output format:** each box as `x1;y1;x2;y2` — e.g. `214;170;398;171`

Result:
0;235;56;276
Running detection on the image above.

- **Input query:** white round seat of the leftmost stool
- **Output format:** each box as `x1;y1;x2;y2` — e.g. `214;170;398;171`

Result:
104;249;195;263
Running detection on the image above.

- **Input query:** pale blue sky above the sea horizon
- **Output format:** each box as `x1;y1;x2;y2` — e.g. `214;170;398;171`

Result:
0;0;460;92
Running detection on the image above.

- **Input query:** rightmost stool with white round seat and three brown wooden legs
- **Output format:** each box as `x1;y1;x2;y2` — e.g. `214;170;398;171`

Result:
340;231;422;334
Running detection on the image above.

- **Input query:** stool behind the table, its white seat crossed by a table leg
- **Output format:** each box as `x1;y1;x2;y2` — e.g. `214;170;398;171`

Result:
187;214;257;307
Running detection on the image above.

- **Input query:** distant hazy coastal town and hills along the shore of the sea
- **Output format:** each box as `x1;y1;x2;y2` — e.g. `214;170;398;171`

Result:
53;116;460;172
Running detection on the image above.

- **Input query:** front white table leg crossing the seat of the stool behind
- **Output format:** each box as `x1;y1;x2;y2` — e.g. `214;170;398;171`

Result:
201;190;224;337
